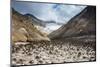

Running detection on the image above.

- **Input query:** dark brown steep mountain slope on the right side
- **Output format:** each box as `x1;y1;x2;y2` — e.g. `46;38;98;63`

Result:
49;6;96;39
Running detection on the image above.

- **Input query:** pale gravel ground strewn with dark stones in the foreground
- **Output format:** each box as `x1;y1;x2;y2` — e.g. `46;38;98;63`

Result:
12;40;96;65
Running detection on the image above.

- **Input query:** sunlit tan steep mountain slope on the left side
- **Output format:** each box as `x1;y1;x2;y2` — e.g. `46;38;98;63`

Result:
12;9;49;42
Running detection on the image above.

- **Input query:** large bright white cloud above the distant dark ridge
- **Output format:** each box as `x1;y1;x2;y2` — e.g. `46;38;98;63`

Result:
33;4;85;23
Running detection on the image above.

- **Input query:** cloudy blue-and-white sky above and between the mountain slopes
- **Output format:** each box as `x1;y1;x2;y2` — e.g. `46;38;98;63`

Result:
11;1;86;30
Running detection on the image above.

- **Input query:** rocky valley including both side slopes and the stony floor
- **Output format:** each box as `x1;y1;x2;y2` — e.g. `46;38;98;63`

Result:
11;6;96;65
